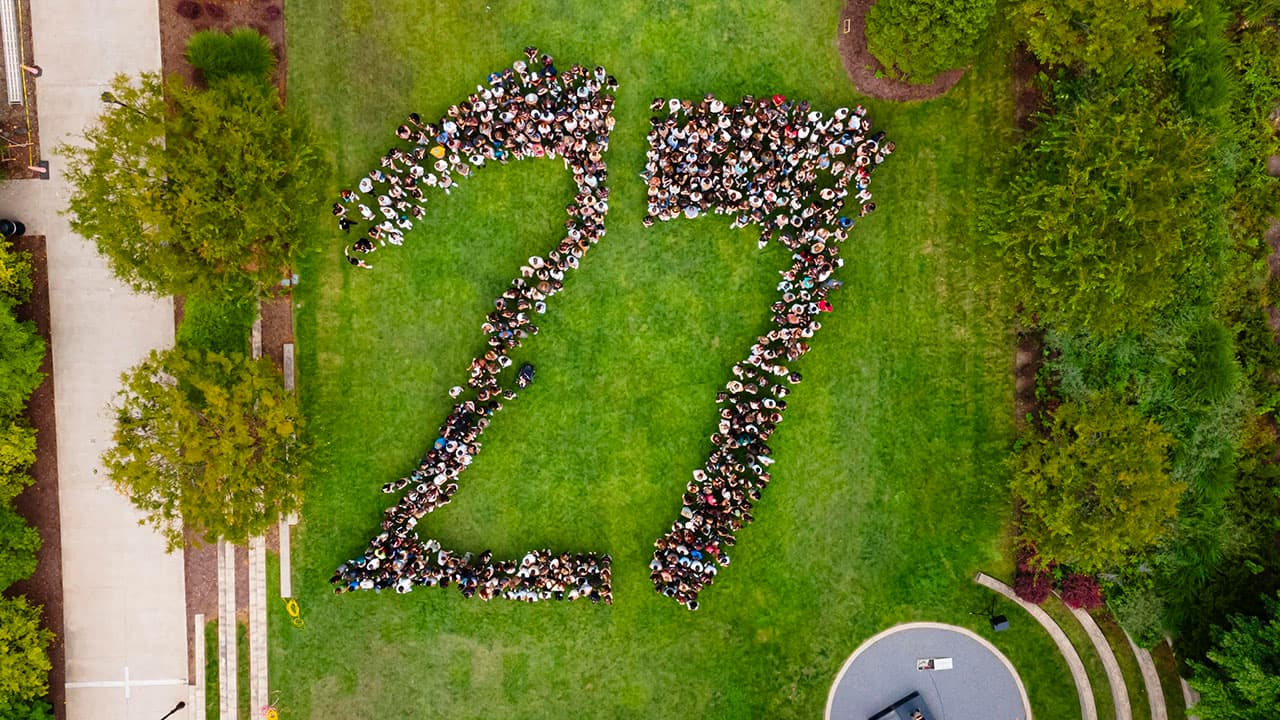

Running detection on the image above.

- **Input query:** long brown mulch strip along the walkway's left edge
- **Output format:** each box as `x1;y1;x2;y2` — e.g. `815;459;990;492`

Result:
8;236;67;720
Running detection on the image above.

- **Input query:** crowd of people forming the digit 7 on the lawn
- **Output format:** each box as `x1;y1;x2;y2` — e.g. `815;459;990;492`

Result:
641;95;893;610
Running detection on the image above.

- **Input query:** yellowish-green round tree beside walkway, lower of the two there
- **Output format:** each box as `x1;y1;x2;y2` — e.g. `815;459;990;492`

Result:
104;348;306;550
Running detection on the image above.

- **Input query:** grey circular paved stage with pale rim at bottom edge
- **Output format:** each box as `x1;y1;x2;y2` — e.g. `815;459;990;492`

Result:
826;623;1030;720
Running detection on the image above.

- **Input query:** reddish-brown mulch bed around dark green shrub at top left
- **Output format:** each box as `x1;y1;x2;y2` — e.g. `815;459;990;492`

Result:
160;0;288;99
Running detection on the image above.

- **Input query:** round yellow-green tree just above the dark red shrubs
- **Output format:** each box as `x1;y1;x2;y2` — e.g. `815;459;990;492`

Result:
1012;393;1183;573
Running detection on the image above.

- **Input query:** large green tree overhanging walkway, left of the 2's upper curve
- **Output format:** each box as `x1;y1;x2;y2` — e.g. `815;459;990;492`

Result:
60;73;325;297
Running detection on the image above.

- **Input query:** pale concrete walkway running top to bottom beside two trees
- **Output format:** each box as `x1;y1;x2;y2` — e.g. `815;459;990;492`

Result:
0;0;189;720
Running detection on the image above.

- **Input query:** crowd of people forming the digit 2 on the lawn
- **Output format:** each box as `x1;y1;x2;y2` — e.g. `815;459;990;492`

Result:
330;47;617;602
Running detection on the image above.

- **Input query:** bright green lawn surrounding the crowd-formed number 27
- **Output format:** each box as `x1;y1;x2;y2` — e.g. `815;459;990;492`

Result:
270;0;1079;720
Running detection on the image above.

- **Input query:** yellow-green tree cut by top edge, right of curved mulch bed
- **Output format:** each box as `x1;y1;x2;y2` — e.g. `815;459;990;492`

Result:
1012;0;1187;70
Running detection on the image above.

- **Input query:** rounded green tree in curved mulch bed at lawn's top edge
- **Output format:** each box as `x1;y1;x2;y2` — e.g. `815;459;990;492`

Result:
867;0;996;83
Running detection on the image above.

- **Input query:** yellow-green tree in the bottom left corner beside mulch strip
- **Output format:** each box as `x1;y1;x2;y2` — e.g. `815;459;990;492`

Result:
0;596;54;705
